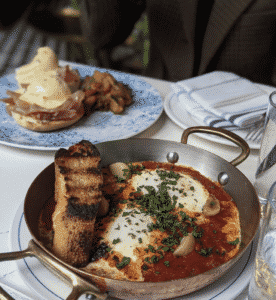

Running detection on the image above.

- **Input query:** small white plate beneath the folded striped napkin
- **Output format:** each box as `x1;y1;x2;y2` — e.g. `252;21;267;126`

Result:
164;84;275;149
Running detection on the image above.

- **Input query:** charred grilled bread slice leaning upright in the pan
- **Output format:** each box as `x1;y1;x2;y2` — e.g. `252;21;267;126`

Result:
53;141;103;266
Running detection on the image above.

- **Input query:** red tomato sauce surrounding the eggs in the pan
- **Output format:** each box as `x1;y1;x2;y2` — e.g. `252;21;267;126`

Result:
37;162;240;282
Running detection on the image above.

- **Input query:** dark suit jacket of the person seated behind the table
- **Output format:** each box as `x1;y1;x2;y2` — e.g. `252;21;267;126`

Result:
82;0;276;85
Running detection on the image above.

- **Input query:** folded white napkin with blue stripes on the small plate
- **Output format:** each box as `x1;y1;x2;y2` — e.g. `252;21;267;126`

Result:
171;71;268;127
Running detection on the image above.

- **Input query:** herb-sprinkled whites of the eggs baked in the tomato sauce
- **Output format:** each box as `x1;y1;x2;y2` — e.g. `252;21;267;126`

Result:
85;169;209;281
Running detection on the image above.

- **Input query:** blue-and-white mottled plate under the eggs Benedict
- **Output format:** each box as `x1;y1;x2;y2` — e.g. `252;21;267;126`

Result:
0;61;163;150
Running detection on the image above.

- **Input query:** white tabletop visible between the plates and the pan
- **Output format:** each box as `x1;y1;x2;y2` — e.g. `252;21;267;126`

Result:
0;77;258;299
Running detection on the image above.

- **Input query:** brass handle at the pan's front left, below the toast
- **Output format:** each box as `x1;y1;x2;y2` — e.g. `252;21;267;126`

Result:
0;240;108;300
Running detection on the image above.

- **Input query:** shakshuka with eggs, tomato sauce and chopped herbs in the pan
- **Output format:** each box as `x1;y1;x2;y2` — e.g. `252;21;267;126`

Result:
39;161;241;282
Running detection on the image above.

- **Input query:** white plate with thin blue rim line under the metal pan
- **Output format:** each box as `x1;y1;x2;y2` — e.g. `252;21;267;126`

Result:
10;203;257;300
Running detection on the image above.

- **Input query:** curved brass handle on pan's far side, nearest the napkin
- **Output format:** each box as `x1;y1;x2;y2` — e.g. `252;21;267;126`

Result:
181;126;250;166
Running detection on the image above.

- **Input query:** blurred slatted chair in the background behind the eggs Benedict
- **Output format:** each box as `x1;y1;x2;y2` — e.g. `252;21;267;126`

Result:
0;1;97;76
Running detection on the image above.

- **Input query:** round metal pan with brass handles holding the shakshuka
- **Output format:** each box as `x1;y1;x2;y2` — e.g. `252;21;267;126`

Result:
0;127;260;299
